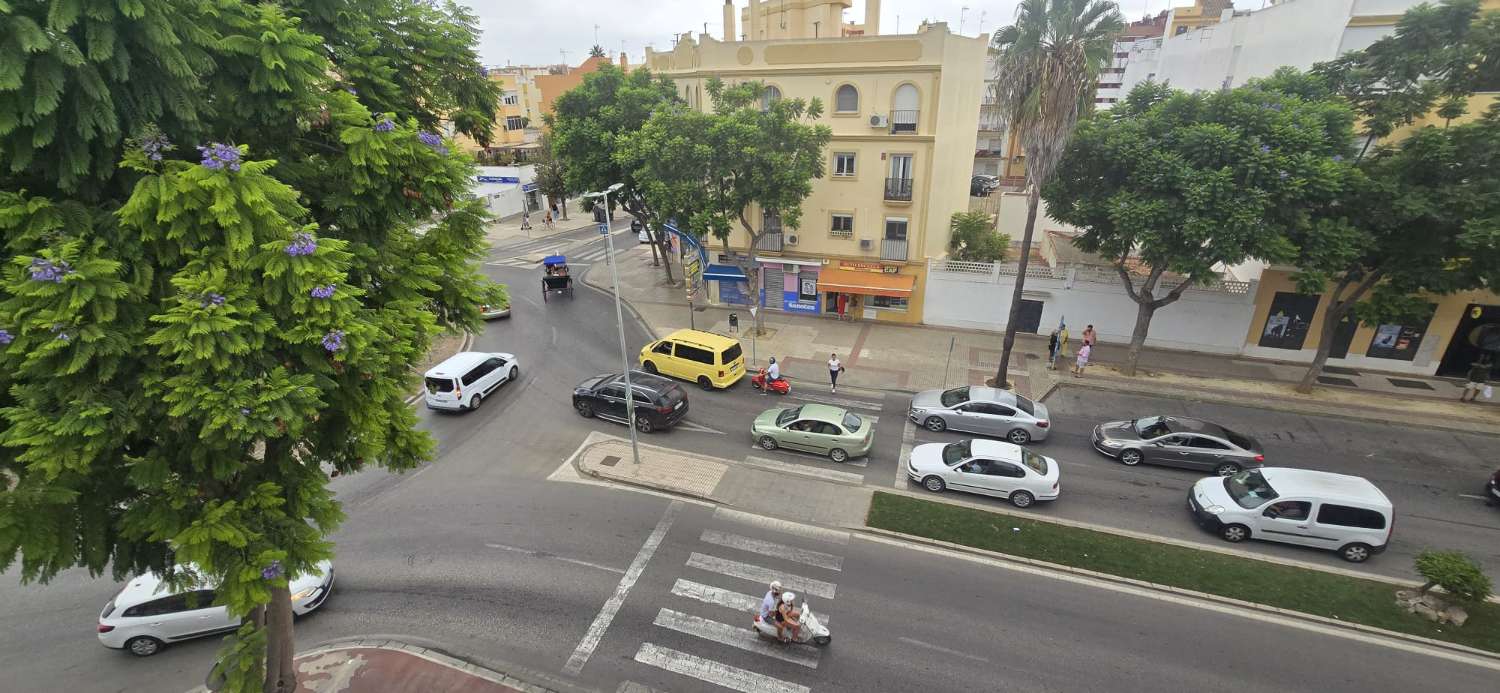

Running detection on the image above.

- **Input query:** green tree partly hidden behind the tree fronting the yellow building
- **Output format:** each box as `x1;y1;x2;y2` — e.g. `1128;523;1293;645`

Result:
546;63;680;284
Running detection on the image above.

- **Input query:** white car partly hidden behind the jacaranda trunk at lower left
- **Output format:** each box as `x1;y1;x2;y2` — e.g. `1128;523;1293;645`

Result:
98;561;333;657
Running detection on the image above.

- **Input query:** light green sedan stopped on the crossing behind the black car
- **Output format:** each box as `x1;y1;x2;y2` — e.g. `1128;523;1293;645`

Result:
750;405;875;462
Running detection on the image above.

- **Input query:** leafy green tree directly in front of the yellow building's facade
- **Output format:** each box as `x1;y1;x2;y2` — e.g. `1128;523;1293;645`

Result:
617;78;833;333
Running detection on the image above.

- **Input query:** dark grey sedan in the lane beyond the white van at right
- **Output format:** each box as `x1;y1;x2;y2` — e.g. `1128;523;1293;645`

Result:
1092;416;1266;477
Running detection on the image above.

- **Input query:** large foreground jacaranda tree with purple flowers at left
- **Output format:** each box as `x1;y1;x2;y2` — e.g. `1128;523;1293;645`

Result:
0;0;501;692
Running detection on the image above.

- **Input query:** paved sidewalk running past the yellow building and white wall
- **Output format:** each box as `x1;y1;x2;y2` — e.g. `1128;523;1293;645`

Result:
584;248;1500;432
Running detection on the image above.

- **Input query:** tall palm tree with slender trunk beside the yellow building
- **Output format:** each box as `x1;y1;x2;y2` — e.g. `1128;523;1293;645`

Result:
992;0;1125;387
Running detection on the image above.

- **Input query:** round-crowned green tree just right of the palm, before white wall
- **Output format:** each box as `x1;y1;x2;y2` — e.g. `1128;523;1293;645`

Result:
1043;73;1353;375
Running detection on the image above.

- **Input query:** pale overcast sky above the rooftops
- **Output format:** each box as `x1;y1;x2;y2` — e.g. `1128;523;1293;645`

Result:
461;0;1263;65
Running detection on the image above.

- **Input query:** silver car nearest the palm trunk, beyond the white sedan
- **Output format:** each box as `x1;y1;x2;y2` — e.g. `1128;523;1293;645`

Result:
908;387;1052;446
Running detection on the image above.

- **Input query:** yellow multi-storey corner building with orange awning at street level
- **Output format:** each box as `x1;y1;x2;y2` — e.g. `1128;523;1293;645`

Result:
647;0;987;323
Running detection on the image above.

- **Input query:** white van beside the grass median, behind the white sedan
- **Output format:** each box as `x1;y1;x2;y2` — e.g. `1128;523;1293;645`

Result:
1188;467;1395;563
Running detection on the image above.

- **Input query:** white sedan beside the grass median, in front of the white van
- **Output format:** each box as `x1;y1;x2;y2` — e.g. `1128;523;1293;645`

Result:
906;440;1061;507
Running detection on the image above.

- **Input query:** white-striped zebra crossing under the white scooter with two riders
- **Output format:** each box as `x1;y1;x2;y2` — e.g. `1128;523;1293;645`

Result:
635;507;849;693
